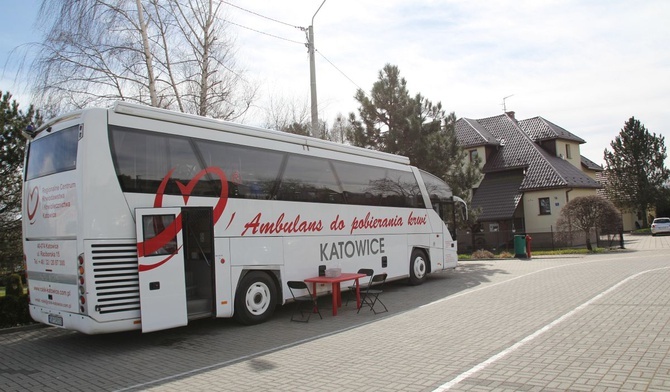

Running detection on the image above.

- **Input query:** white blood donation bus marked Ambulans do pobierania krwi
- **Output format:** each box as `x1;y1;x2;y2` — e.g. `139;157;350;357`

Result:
23;102;457;334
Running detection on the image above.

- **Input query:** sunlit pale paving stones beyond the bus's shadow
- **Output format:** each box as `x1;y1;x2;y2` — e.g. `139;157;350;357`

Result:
142;236;670;391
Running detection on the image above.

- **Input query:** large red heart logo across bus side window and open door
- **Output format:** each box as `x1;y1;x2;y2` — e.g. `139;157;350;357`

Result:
137;167;228;272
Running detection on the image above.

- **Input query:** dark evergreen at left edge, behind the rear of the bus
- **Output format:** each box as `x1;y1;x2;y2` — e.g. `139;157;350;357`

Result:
0;91;41;270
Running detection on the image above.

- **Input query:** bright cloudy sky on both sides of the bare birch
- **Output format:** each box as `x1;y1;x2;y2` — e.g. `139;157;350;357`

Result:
0;0;670;166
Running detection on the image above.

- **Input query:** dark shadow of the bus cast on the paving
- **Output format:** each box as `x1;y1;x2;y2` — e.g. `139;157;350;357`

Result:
0;262;507;390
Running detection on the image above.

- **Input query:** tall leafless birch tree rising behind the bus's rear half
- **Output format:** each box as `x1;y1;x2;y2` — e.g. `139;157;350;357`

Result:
32;0;257;119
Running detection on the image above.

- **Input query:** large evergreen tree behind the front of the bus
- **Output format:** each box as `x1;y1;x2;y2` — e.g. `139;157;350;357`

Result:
347;64;481;198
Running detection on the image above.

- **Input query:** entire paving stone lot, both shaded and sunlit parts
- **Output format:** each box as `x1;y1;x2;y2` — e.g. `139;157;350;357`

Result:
0;236;670;392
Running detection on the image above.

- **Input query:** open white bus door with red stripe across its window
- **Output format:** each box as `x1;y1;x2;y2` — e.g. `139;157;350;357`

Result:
135;208;188;332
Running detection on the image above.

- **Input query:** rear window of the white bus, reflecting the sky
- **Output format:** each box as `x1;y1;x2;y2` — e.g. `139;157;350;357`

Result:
26;125;79;180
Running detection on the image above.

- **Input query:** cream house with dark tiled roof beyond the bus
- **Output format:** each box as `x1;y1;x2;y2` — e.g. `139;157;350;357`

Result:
456;112;603;249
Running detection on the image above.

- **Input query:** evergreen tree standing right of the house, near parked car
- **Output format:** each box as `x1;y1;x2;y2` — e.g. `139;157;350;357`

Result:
605;117;670;227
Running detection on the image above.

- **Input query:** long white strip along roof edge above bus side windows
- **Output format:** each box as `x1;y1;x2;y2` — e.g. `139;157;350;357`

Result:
111;101;410;165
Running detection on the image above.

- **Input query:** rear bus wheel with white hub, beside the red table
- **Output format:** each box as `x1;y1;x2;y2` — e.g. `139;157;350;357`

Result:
233;271;277;325
